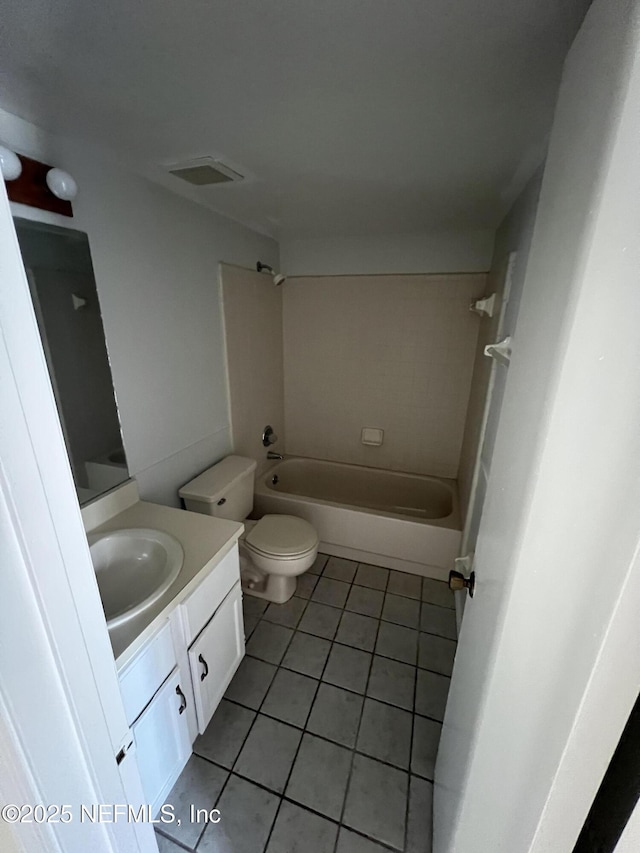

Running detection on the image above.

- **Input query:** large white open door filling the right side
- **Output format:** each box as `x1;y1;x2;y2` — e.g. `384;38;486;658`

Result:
434;0;640;853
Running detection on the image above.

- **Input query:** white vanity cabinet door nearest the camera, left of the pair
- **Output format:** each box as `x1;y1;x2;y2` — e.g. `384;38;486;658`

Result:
132;668;191;814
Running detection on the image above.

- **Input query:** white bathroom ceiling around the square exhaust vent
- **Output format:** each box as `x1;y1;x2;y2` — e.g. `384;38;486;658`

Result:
0;0;589;237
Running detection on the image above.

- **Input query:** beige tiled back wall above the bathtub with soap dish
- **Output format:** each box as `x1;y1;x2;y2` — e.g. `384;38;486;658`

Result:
284;274;485;477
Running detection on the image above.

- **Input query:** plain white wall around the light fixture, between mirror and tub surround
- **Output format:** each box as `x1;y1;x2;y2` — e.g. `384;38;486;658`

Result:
0;106;278;504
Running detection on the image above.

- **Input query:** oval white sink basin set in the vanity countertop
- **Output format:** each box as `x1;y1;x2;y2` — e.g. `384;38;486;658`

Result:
89;527;184;628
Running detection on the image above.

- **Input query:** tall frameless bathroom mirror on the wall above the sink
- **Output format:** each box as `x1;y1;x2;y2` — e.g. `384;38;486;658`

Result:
14;218;129;505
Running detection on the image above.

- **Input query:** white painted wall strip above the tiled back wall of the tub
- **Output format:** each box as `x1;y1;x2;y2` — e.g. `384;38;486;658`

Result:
280;229;495;276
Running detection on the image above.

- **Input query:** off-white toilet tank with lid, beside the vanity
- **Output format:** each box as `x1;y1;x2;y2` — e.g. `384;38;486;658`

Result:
178;456;257;521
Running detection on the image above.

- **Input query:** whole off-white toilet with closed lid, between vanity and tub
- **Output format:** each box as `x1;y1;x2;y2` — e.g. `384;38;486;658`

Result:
179;456;319;604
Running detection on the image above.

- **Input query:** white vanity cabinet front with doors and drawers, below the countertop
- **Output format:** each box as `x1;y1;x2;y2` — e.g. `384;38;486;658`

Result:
118;544;244;814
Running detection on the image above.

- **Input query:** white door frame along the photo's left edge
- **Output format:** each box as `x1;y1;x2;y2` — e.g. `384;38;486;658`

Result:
0;176;157;853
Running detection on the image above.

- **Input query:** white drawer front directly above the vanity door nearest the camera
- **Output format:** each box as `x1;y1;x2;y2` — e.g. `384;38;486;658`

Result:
118;621;176;725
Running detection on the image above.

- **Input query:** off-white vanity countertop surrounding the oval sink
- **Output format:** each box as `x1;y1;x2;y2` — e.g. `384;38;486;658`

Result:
89;501;244;670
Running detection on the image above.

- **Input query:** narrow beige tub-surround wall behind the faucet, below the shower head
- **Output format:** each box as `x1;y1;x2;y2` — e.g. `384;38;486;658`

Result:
220;264;285;465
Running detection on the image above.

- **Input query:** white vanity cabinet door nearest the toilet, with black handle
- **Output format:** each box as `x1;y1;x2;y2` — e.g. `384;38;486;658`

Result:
189;583;244;734
